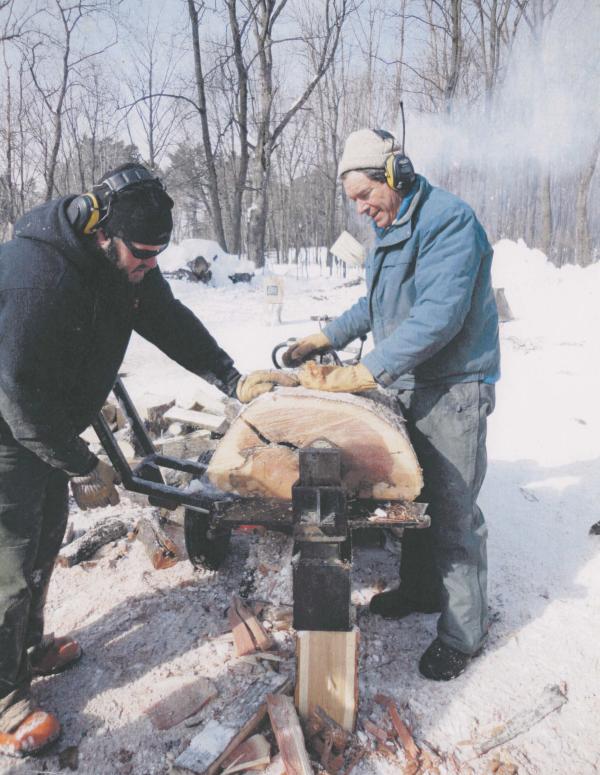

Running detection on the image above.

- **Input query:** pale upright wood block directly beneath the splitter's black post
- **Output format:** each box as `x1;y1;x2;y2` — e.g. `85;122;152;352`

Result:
296;628;358;732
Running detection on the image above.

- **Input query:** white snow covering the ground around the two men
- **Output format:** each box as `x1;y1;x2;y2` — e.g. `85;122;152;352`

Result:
5;241;600;775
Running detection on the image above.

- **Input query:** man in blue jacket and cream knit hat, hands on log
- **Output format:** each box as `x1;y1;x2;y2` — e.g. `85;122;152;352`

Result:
284;129;500;680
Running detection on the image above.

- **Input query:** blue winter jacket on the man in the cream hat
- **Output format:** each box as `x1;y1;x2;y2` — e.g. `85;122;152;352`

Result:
324;175;500;389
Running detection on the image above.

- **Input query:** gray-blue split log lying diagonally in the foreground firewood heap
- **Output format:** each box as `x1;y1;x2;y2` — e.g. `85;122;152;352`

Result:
173;673;290;775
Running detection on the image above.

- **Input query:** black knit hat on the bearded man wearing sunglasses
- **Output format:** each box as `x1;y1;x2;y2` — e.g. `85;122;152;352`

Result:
94;164;173;245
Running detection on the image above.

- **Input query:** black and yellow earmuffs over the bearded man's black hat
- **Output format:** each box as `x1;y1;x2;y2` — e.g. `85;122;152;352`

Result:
67;164;165;235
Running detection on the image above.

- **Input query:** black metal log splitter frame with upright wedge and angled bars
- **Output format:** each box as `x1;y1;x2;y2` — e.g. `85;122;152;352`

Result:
93;378;430;596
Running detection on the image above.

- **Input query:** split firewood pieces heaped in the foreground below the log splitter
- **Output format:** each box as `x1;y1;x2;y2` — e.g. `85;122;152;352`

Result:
145;595;436;775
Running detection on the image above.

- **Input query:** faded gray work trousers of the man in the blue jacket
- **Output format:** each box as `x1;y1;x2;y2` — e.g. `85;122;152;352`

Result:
398;382;495;654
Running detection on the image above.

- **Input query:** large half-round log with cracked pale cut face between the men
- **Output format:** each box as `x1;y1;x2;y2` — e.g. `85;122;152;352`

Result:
207;388;423;501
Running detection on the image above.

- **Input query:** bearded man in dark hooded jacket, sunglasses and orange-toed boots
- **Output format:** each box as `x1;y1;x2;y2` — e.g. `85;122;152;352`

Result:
0;164;291;756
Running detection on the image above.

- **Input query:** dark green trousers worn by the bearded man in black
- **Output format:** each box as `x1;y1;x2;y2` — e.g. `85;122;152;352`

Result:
0;436;68;698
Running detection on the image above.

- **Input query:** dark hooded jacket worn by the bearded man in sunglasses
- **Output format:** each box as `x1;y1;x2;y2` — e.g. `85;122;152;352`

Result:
0;198;239;474
